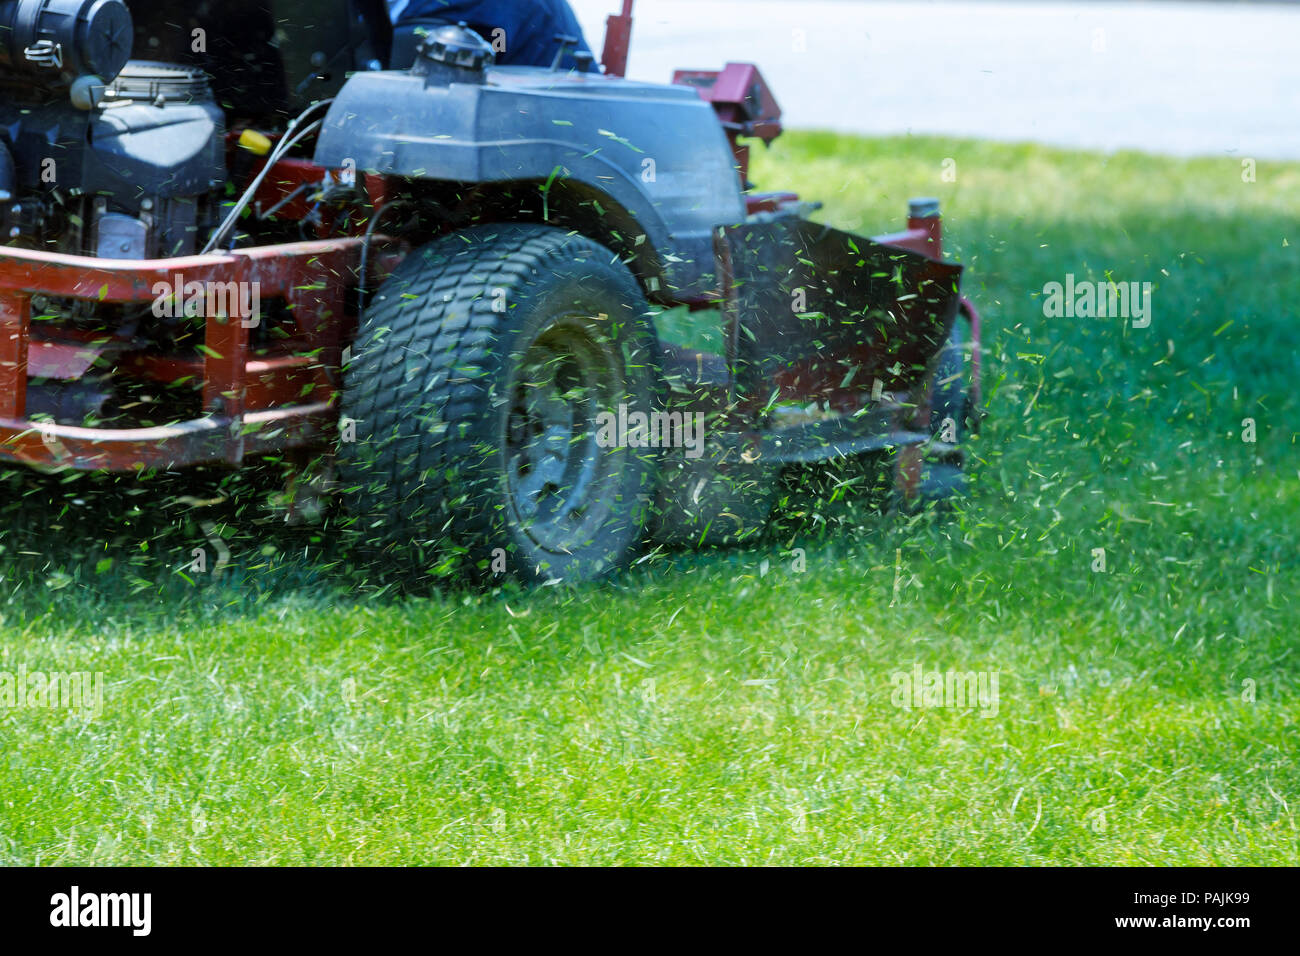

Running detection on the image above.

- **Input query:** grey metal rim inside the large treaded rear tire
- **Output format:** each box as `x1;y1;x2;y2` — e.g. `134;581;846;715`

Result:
506;315;625;554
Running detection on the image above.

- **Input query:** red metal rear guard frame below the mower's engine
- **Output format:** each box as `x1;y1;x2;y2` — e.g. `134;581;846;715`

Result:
0;238;363;472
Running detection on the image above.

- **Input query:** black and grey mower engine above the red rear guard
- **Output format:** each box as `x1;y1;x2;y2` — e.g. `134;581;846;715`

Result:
0;0;226;259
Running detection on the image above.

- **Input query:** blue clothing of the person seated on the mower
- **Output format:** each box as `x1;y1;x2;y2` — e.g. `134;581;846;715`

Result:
387;0;592;69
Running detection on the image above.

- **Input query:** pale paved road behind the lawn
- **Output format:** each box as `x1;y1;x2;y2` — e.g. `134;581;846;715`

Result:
573;0;1300;159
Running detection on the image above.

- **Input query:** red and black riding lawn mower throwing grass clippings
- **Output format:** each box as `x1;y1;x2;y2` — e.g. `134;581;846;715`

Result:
0;0;979;581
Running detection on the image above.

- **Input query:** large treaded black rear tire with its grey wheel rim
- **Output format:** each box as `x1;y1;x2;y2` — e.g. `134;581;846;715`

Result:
339;224;659;581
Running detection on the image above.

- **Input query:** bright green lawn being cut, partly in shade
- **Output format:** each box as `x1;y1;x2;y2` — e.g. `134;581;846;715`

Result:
0;134;1300;865
